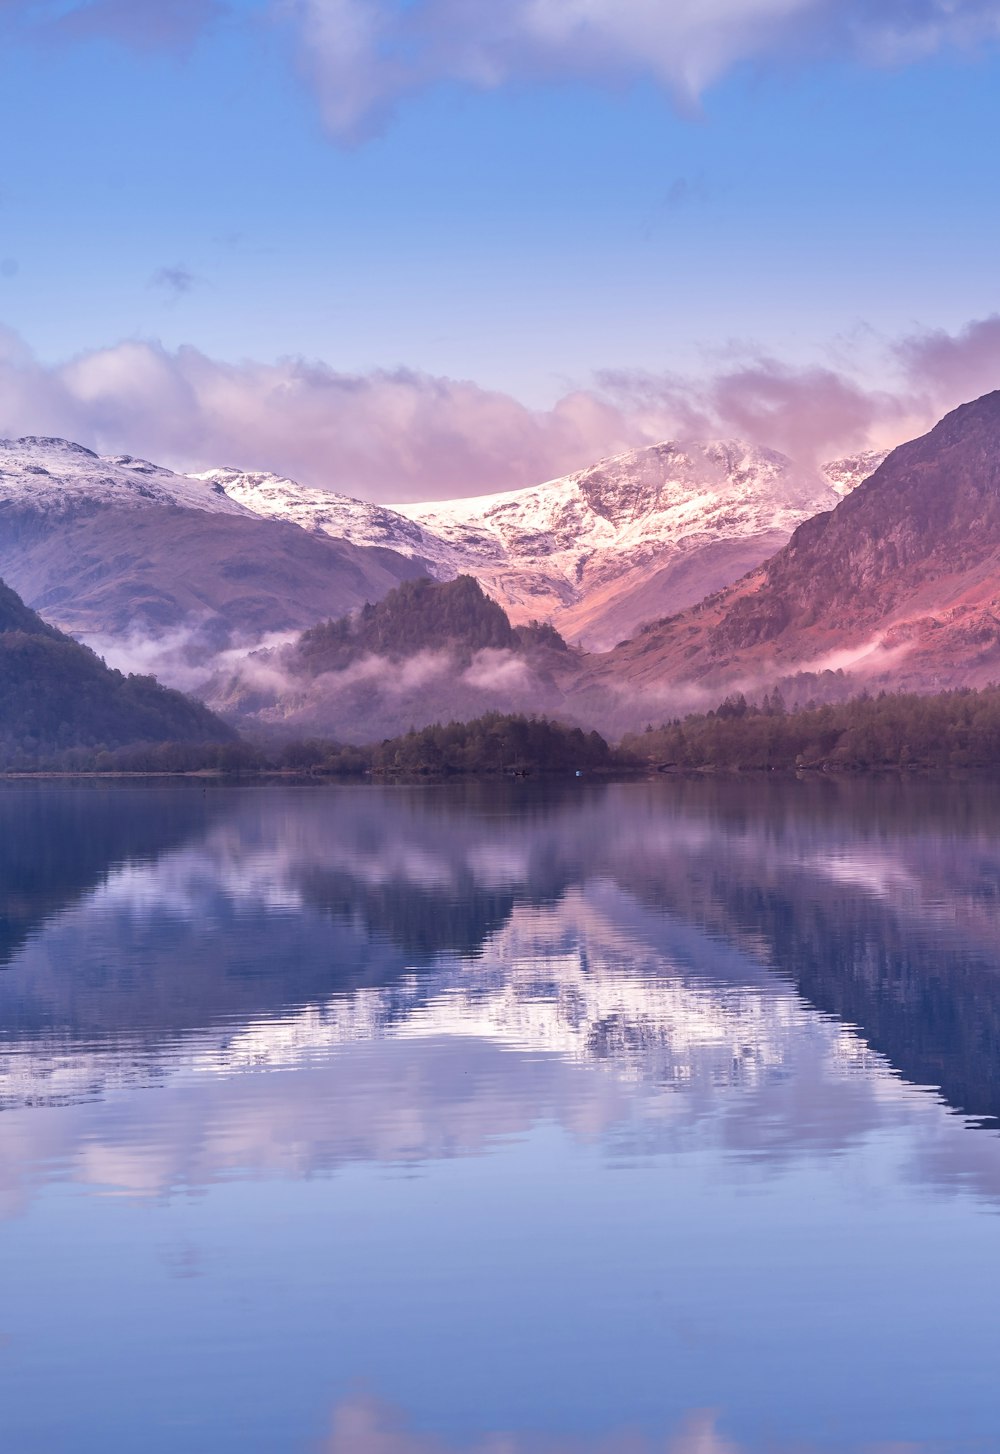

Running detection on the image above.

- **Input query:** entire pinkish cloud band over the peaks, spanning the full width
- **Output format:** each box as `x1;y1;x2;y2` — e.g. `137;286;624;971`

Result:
0;315;1000;502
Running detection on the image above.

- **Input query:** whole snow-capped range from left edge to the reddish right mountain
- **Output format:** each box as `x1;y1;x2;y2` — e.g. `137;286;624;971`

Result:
0;438;879;686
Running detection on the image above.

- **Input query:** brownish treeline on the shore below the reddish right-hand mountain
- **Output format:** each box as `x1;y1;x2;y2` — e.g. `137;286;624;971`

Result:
622;686;1000;771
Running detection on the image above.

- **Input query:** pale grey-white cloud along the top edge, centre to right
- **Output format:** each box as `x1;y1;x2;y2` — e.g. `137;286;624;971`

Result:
275;0;1000;140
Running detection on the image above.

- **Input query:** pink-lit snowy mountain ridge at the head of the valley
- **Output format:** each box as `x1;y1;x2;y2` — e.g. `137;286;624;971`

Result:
203;441;884;650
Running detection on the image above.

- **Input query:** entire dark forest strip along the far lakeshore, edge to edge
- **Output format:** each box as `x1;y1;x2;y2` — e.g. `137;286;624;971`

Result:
9;679;1000;779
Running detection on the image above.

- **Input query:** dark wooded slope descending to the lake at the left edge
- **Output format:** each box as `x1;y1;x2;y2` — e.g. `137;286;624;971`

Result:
0;582;235;762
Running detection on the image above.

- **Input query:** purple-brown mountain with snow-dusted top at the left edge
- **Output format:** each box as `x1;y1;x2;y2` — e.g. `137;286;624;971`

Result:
0;438;423;654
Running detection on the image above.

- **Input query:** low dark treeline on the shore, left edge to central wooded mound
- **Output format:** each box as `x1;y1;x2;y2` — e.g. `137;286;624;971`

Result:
3;712;624;778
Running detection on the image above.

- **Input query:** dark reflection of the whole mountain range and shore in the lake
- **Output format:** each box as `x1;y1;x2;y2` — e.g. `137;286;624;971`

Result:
0;784;1000;1115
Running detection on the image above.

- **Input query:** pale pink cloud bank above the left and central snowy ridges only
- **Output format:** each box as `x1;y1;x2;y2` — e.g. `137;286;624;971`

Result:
0;333;641;500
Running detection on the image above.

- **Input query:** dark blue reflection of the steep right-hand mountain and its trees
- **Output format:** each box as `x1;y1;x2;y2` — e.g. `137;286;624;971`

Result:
610;782;1000;1118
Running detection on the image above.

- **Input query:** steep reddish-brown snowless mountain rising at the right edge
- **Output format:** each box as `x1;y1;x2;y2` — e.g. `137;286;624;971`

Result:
594;391;1000;694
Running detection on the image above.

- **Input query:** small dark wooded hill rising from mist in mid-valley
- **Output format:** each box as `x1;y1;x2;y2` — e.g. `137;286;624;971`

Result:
293;576;565;675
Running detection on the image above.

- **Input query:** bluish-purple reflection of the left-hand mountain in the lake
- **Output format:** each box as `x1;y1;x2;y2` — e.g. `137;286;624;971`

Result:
0;790;593;1051
